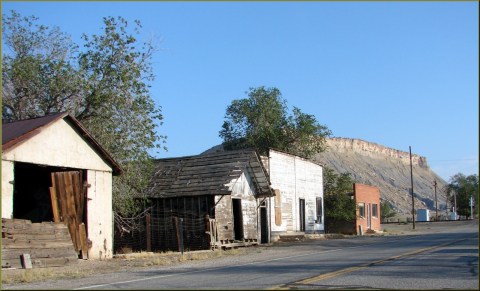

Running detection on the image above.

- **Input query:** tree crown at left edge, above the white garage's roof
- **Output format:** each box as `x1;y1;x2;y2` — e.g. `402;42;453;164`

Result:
2;11;81;121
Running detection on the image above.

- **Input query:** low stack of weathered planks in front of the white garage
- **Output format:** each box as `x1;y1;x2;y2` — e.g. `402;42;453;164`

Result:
2;218;78;268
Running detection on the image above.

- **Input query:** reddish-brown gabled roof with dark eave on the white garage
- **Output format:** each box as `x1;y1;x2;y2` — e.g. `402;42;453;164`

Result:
2;112;122;175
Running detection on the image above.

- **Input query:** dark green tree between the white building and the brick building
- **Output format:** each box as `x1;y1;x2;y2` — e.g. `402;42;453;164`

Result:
323;167;356;232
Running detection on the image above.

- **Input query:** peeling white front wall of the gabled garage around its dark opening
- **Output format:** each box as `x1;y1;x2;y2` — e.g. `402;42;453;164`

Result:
2;119;113;259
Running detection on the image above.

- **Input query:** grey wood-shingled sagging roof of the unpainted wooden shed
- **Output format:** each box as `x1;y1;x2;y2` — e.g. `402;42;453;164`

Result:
145;150;275;198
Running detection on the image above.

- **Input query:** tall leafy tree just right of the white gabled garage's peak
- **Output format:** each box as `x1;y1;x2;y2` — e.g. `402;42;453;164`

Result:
75;17;165;216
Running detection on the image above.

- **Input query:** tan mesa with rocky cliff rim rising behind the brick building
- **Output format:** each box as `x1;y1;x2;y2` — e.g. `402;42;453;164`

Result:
314;138;446;217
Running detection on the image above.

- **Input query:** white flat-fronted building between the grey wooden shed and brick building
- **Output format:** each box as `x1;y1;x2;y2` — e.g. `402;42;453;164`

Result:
262;149;324;241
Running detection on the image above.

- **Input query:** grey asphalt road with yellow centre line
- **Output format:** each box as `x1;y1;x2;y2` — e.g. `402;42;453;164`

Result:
4;223;479;290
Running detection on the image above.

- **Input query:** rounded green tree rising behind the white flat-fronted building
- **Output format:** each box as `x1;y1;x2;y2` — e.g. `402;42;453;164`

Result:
219;87;331;158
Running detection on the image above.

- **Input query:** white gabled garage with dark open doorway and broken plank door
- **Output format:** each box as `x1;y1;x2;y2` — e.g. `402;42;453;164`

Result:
2;113;121;259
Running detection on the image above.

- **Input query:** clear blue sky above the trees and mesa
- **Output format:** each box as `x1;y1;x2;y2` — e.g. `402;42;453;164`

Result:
2;1;479;181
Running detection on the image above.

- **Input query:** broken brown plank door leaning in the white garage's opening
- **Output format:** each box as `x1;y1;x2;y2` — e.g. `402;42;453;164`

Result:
50;171;88;259
